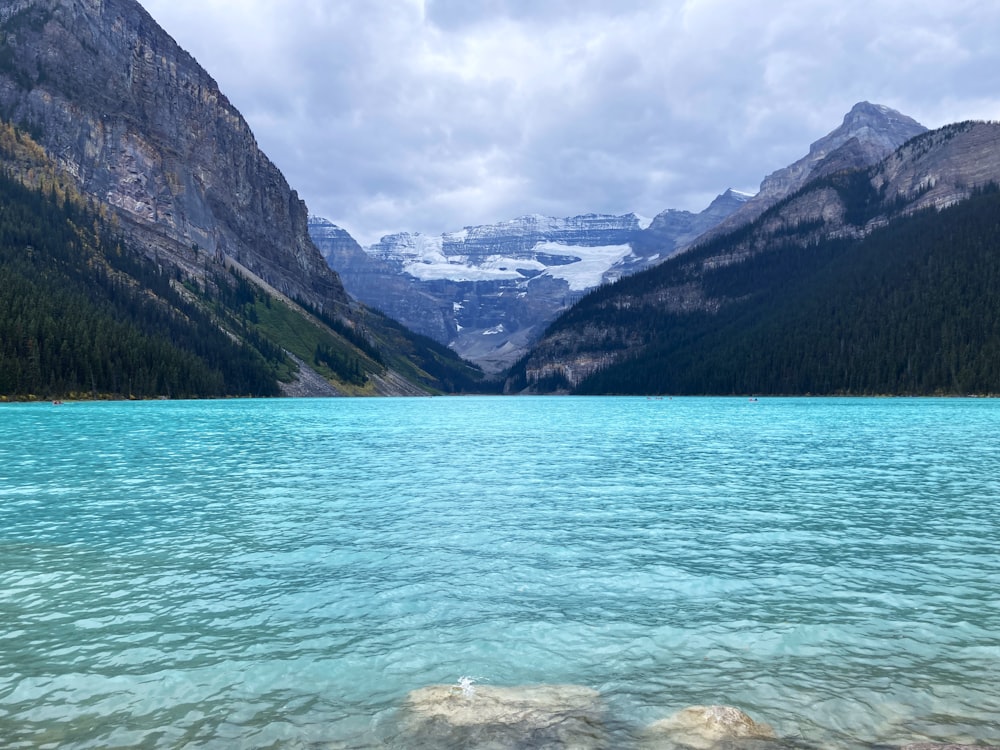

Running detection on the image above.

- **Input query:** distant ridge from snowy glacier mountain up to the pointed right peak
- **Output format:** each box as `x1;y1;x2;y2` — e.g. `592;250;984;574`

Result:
310;102;926;373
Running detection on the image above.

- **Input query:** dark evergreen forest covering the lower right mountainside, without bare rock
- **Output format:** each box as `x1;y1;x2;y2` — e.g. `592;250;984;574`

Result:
557;183;1000;395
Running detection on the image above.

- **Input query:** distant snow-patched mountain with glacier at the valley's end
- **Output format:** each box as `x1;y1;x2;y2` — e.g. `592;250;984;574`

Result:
309;191;747;372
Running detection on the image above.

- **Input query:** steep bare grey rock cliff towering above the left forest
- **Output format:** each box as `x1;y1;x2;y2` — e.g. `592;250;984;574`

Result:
0;0;484;400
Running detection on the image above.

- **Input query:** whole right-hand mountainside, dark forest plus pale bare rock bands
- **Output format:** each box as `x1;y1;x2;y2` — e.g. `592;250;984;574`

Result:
506;118;1000;395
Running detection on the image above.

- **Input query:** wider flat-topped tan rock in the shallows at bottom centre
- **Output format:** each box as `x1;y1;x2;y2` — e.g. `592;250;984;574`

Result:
401;682;607;750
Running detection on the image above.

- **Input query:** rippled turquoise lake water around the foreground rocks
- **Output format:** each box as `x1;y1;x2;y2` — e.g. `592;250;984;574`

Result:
0;398;1000;748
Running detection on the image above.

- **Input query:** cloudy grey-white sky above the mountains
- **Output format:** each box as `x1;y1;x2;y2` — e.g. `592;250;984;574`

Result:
140;0;1000;244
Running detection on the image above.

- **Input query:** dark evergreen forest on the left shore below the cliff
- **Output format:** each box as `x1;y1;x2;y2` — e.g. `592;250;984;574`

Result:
0;174;284;398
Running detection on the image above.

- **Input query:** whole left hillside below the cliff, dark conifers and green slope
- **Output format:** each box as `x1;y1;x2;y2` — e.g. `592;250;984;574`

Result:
0;164;492;399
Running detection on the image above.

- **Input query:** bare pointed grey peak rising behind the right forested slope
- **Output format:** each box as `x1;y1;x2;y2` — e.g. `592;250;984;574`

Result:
701;102;927;240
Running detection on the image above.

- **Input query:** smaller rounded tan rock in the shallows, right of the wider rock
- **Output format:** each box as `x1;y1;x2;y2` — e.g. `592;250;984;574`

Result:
643;706;775;750
